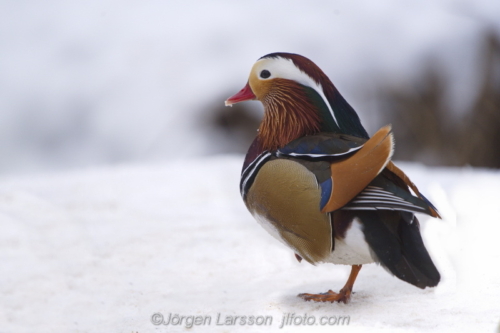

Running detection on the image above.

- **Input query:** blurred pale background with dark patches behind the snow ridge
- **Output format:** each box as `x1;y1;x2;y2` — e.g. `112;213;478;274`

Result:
0;0;500;176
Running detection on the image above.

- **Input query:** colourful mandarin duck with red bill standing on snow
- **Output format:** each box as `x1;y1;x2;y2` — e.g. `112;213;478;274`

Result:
226;53;440;303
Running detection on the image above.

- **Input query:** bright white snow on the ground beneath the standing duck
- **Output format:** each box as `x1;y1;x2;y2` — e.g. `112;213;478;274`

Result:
0;155;500;332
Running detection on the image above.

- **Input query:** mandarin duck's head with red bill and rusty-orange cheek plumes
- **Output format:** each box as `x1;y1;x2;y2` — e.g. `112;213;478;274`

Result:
226;53;368;150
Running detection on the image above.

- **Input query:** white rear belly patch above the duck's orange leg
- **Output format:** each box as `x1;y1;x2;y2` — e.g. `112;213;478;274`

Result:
325;218;375;265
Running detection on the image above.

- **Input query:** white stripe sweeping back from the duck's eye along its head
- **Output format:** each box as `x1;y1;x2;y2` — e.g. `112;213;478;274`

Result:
254;57;340;128
